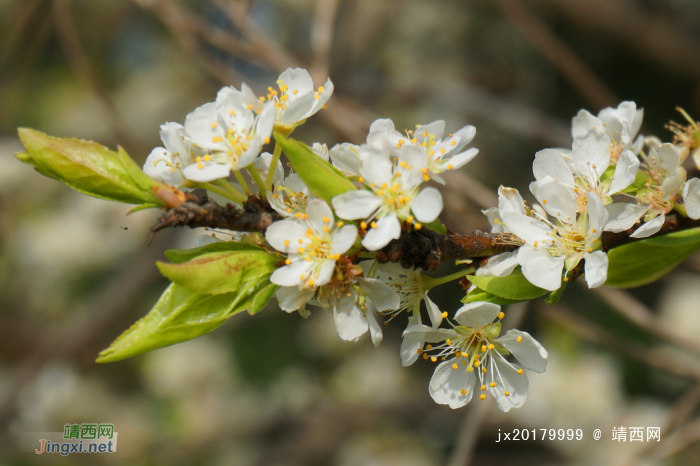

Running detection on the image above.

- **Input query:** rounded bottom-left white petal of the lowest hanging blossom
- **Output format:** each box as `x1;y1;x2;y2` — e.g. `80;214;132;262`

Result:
430;359;476;409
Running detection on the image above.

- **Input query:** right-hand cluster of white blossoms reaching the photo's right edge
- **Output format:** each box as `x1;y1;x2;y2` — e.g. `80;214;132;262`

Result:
478;102;700;291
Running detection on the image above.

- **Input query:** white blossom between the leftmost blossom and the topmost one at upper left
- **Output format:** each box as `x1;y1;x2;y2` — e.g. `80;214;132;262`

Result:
183;87;275;182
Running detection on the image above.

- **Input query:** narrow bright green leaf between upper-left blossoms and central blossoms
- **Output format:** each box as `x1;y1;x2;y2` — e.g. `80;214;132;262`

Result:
275;133;356;202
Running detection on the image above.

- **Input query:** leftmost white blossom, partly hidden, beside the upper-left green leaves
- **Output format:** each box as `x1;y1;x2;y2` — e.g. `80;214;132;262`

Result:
143;123;192;187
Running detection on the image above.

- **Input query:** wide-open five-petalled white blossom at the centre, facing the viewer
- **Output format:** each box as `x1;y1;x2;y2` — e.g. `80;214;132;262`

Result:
332;146;443;251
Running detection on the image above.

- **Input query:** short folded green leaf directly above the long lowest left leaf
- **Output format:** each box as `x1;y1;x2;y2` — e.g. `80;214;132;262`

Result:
156;250;279;294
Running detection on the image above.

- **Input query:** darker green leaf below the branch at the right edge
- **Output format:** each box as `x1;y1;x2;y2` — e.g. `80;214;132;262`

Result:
605;228;700;288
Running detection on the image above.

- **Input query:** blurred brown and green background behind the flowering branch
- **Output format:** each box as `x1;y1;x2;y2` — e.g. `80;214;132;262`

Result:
0;0;700;466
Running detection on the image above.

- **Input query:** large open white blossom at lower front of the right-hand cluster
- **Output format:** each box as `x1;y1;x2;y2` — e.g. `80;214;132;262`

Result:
501;187;608;291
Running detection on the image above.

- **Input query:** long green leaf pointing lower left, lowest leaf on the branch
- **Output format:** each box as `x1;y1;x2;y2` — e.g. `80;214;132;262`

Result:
97;278;275;363
